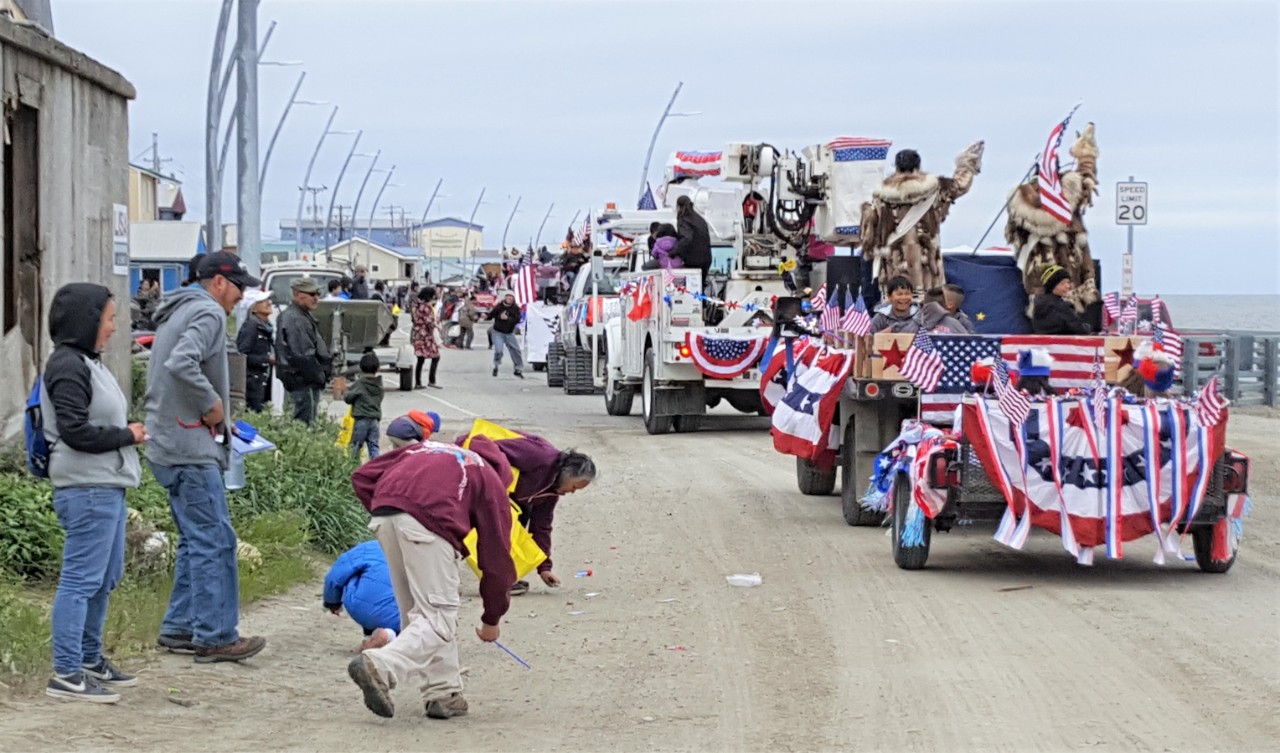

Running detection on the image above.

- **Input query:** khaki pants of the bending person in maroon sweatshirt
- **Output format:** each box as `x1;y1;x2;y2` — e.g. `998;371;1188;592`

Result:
365;512;462;702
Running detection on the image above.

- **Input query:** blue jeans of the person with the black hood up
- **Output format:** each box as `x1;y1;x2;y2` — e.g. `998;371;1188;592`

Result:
50;487;128;675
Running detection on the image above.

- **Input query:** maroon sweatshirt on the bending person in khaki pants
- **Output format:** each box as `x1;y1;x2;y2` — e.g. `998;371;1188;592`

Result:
351;437;516;625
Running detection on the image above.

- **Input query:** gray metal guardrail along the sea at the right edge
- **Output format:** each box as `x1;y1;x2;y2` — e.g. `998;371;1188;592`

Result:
1181;332;1280;407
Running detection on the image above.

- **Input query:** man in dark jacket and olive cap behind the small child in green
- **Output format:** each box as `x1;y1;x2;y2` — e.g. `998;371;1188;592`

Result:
275;277;333;424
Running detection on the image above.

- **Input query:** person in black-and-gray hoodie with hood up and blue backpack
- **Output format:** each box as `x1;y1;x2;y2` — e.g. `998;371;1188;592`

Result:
41;283;146;703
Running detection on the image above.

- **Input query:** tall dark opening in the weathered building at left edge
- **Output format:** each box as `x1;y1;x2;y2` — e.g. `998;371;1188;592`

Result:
3;105;39;346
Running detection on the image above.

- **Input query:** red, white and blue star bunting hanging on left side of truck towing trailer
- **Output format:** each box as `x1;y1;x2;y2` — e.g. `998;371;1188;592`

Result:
771;347;854;467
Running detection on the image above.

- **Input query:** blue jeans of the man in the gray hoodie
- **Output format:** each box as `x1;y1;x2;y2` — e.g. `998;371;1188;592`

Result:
151;464;239;648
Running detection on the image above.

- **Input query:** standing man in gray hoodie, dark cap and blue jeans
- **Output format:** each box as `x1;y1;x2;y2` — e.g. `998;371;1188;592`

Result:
146;251;266;662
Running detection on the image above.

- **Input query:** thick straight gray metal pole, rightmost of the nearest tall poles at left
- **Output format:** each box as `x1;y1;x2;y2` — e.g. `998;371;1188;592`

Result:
236;0;262;274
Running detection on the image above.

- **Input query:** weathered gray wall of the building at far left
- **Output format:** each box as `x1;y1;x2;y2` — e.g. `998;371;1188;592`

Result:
0;18;134;439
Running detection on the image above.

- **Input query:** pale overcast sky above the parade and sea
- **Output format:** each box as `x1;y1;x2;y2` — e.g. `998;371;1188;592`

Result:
52;0;1280;293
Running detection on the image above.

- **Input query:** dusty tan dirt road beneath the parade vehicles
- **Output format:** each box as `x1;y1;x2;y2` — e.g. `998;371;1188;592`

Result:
0;338;1280;753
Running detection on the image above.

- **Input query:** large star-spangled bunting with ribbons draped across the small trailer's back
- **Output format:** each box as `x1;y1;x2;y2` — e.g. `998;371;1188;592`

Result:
964;397;1226;563
